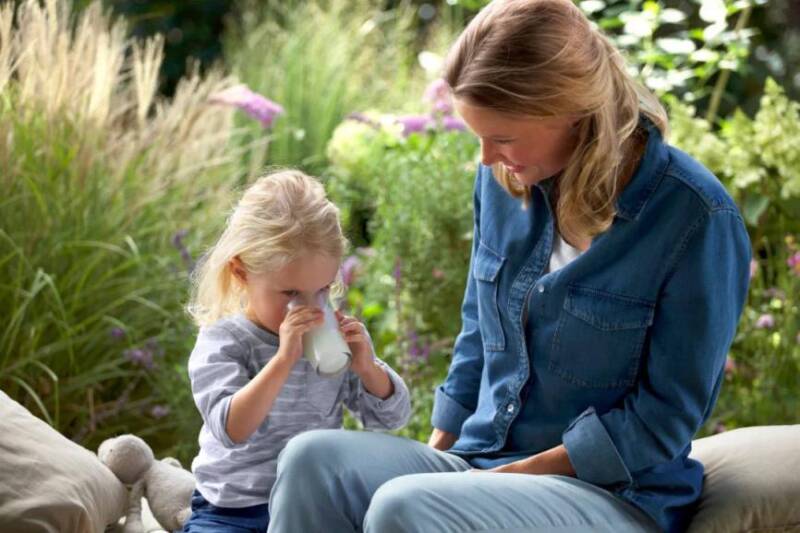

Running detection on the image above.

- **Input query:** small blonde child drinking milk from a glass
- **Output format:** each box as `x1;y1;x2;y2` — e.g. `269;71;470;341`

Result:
184;170;411;532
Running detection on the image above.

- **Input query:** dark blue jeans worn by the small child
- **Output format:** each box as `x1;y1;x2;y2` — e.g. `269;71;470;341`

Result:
183;490;269;533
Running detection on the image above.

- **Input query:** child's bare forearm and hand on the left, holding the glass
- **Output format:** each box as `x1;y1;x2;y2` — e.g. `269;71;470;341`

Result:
225;307;322;444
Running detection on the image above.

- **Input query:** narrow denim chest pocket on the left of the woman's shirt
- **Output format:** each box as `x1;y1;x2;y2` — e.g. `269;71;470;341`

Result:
472;242;506;352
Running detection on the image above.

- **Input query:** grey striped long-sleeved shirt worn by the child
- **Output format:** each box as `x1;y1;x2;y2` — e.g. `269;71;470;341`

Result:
189;315;411;507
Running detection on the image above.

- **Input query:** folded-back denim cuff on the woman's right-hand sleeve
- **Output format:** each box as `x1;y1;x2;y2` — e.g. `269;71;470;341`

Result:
562;407;633;486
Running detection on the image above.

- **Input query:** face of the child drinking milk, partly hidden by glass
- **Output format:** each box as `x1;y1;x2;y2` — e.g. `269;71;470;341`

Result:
236;254;339;333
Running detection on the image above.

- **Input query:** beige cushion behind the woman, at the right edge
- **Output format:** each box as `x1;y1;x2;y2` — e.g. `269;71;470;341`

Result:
689;425;800;533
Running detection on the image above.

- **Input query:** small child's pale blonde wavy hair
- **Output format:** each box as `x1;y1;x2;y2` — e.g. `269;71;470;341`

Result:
188;170;347;326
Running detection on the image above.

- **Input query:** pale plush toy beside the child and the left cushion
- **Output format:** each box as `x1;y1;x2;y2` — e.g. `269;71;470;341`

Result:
97;435;195;531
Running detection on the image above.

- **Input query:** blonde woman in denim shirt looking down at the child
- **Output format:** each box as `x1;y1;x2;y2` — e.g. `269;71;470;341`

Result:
270;0;757;533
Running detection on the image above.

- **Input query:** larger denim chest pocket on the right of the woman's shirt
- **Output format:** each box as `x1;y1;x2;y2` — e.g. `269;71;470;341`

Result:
548;286;655;389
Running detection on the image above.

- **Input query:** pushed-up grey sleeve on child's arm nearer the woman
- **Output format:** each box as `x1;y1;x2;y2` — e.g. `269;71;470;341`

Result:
346;359;411;429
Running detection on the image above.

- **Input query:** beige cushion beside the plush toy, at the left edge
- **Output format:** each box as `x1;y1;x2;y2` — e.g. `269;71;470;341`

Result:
0;391;127;533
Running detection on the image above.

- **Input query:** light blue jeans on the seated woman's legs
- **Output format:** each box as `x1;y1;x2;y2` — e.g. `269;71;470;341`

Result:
269;430;658;533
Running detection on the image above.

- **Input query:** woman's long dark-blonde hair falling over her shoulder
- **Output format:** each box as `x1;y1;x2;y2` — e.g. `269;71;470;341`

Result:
445;0;668;240
